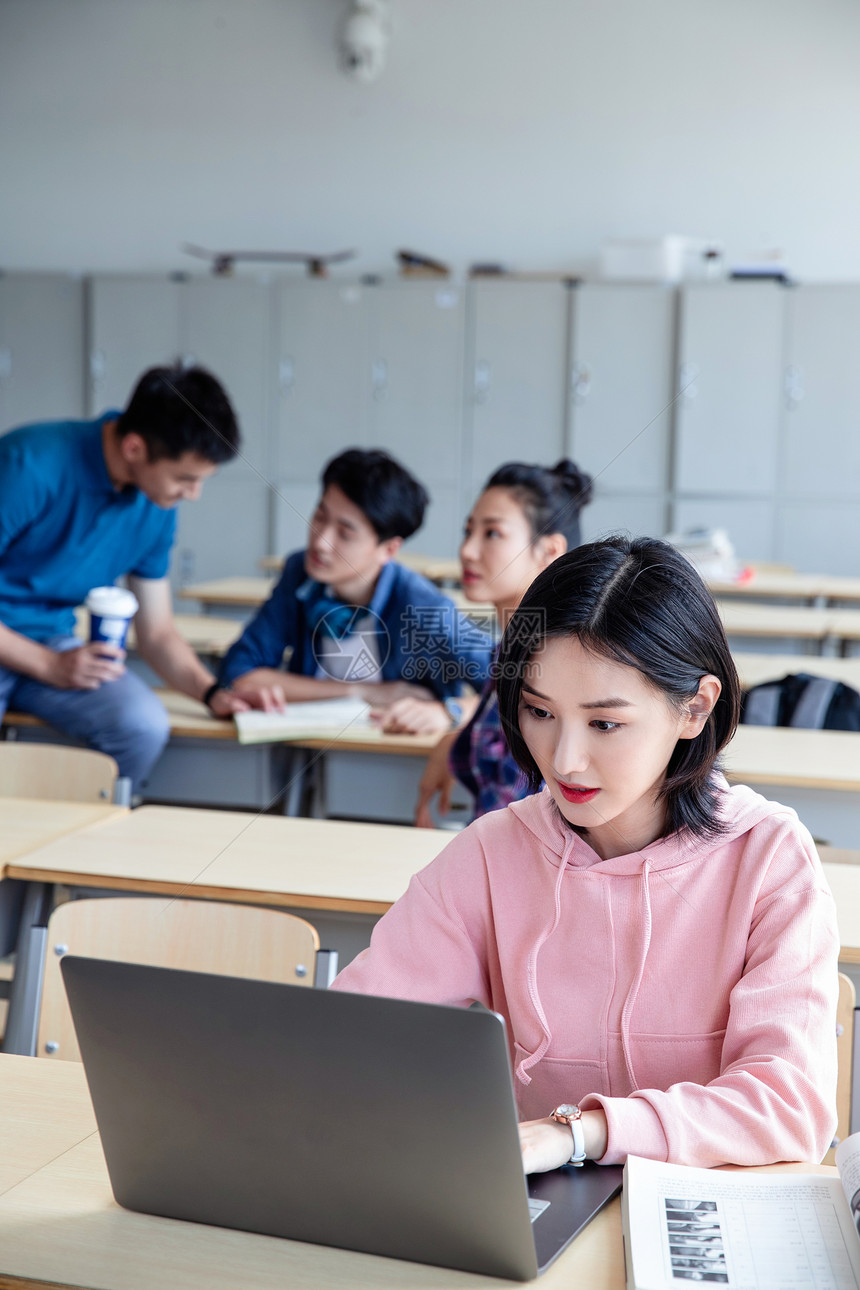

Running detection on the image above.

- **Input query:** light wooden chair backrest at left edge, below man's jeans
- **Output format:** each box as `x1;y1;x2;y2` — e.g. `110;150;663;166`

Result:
0;739;120;802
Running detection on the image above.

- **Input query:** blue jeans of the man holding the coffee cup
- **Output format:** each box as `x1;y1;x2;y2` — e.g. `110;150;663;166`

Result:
0;636;170;792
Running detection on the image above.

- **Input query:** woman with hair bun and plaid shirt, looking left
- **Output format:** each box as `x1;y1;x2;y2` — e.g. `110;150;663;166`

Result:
415;459;592;828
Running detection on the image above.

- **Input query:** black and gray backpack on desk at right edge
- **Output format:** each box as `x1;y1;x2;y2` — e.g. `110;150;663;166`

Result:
740;672;860;730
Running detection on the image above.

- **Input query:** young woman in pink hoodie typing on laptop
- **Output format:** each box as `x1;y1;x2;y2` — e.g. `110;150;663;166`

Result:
335;538;838;1171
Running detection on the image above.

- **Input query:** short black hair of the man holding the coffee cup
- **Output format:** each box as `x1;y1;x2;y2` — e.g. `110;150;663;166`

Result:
116;362;241;466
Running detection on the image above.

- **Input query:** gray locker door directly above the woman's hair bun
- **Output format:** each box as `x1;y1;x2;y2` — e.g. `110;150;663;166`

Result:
465;281;570;491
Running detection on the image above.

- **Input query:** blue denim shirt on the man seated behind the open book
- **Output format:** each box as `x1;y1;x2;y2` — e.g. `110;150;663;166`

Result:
219;551;493;700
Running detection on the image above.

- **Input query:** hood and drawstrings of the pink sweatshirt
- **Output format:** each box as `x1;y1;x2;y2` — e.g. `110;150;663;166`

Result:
508;777;794;1090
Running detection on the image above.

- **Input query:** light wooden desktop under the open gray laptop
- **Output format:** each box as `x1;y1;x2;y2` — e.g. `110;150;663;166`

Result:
0;1055;836;1290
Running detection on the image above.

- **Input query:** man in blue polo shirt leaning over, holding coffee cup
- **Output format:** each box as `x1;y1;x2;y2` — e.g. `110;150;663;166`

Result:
0;366;252;788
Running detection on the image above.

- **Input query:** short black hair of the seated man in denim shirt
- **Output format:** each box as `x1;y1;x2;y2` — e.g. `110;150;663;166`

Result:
322;448;429;542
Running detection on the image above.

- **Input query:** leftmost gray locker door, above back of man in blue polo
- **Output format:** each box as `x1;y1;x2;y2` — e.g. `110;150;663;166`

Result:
0;273;85;431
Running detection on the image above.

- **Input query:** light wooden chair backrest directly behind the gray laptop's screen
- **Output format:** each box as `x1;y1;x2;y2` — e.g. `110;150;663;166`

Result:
36;897;320;1062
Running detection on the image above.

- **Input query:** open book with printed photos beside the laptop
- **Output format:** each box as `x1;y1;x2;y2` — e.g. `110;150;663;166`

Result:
621;1134;860;1290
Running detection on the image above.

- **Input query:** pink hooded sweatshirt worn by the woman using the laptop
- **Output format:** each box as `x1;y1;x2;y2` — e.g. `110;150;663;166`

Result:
334;782;838;1166
